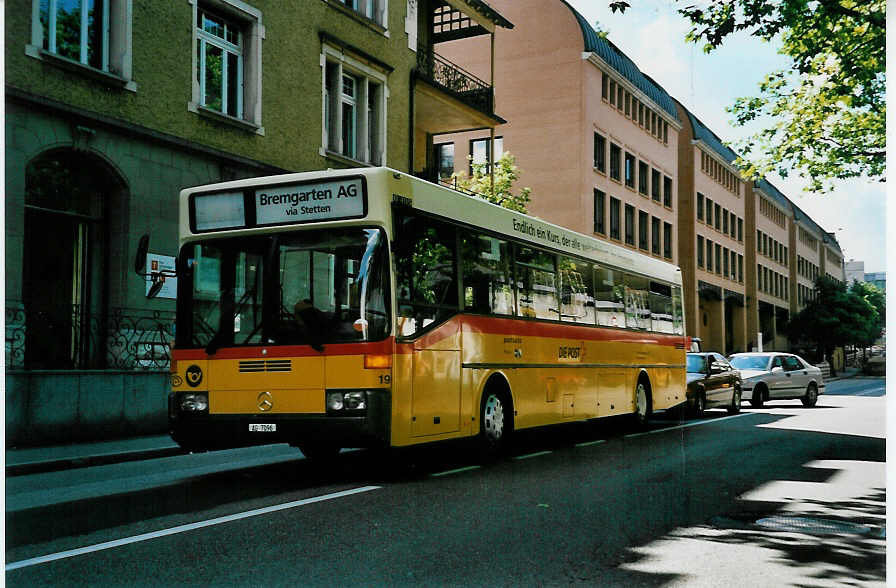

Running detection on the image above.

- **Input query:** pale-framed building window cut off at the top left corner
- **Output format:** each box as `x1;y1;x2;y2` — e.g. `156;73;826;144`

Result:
31;0;137;90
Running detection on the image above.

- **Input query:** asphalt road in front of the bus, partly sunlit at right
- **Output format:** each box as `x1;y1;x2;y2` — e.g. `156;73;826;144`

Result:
6;379;885;586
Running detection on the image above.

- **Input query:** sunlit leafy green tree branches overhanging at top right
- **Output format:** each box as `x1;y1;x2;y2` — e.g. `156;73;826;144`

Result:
610;0;886;191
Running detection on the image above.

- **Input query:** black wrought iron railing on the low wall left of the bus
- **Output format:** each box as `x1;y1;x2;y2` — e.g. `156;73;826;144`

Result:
6;301;175;371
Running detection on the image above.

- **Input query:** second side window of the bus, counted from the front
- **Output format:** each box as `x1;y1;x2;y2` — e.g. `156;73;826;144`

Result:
461;232;513;315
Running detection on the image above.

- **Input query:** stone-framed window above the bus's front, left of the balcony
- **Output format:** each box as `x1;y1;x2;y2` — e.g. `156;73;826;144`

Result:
321;45;387;165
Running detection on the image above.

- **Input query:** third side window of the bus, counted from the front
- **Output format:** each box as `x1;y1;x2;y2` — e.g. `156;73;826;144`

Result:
515;245;560;320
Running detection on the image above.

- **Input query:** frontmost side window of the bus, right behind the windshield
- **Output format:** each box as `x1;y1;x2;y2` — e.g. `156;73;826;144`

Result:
394;213;458;336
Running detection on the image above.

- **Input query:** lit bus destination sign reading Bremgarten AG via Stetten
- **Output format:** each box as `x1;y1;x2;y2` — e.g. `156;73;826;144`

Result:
255;178;367;225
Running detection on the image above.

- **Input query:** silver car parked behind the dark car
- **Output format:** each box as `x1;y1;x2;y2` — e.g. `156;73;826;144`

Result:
728;351;824;408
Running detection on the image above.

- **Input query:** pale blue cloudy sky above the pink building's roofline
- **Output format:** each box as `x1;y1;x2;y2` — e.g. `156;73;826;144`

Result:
568;0;887;272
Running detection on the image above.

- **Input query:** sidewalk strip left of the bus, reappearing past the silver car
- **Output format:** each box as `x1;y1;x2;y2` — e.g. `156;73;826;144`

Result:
6;367;860;476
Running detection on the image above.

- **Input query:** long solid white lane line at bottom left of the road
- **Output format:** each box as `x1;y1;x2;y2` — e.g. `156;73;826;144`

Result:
6;486;381;572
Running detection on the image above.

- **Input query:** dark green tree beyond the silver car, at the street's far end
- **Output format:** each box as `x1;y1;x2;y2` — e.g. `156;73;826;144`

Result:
787;276;881;373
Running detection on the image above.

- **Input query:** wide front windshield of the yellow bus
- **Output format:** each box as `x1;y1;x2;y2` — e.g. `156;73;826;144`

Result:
177;228;390;353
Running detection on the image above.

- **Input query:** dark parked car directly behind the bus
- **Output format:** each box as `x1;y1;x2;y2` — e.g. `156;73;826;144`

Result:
687;351;741;415
